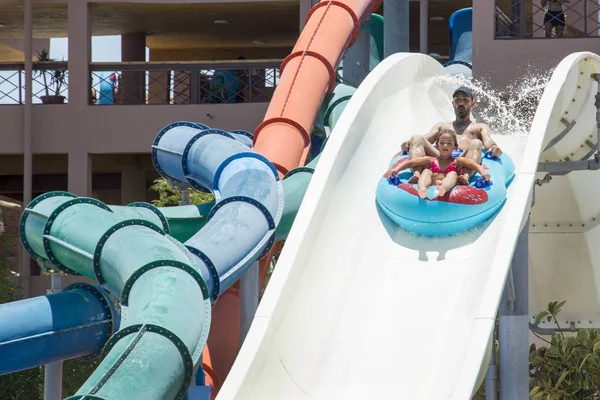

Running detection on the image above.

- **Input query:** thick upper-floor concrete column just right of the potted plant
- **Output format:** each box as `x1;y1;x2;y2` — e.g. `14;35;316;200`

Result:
67;0;92;107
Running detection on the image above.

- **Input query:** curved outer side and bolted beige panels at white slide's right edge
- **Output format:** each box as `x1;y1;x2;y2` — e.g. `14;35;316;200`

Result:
529;53;600;332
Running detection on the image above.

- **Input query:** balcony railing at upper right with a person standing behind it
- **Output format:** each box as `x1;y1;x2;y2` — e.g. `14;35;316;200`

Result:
495;0;600;39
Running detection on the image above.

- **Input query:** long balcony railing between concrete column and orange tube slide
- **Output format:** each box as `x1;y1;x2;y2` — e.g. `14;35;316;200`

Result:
90;60;281;105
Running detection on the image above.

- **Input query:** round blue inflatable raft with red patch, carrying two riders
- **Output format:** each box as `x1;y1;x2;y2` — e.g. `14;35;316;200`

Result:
376;153;515;236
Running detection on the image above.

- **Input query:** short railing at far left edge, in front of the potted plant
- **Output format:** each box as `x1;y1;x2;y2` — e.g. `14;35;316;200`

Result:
0;62;69;105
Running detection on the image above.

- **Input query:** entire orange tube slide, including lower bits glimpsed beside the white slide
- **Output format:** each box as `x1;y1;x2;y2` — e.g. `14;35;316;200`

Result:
204;0;381;398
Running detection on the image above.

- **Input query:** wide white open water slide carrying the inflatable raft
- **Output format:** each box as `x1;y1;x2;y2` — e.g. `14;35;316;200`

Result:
218;53;600;400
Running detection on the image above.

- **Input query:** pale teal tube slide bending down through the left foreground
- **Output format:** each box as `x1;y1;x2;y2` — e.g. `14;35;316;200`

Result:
21;192;210;399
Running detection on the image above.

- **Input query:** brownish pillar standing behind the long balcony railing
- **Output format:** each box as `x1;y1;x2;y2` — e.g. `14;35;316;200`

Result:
119;32;146;104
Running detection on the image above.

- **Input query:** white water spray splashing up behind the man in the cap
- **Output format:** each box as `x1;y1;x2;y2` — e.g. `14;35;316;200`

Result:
442;69;551;136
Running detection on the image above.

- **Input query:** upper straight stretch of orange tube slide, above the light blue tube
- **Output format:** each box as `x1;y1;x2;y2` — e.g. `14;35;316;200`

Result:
253;0;381;177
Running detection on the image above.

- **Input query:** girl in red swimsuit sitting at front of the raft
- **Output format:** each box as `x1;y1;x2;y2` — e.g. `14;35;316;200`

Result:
389;130;490;199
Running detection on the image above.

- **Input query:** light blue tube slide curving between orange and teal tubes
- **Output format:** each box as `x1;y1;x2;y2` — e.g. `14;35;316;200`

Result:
152;122;283;301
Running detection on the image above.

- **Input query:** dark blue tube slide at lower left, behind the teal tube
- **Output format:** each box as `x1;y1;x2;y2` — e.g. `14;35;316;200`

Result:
0;283;120;375
